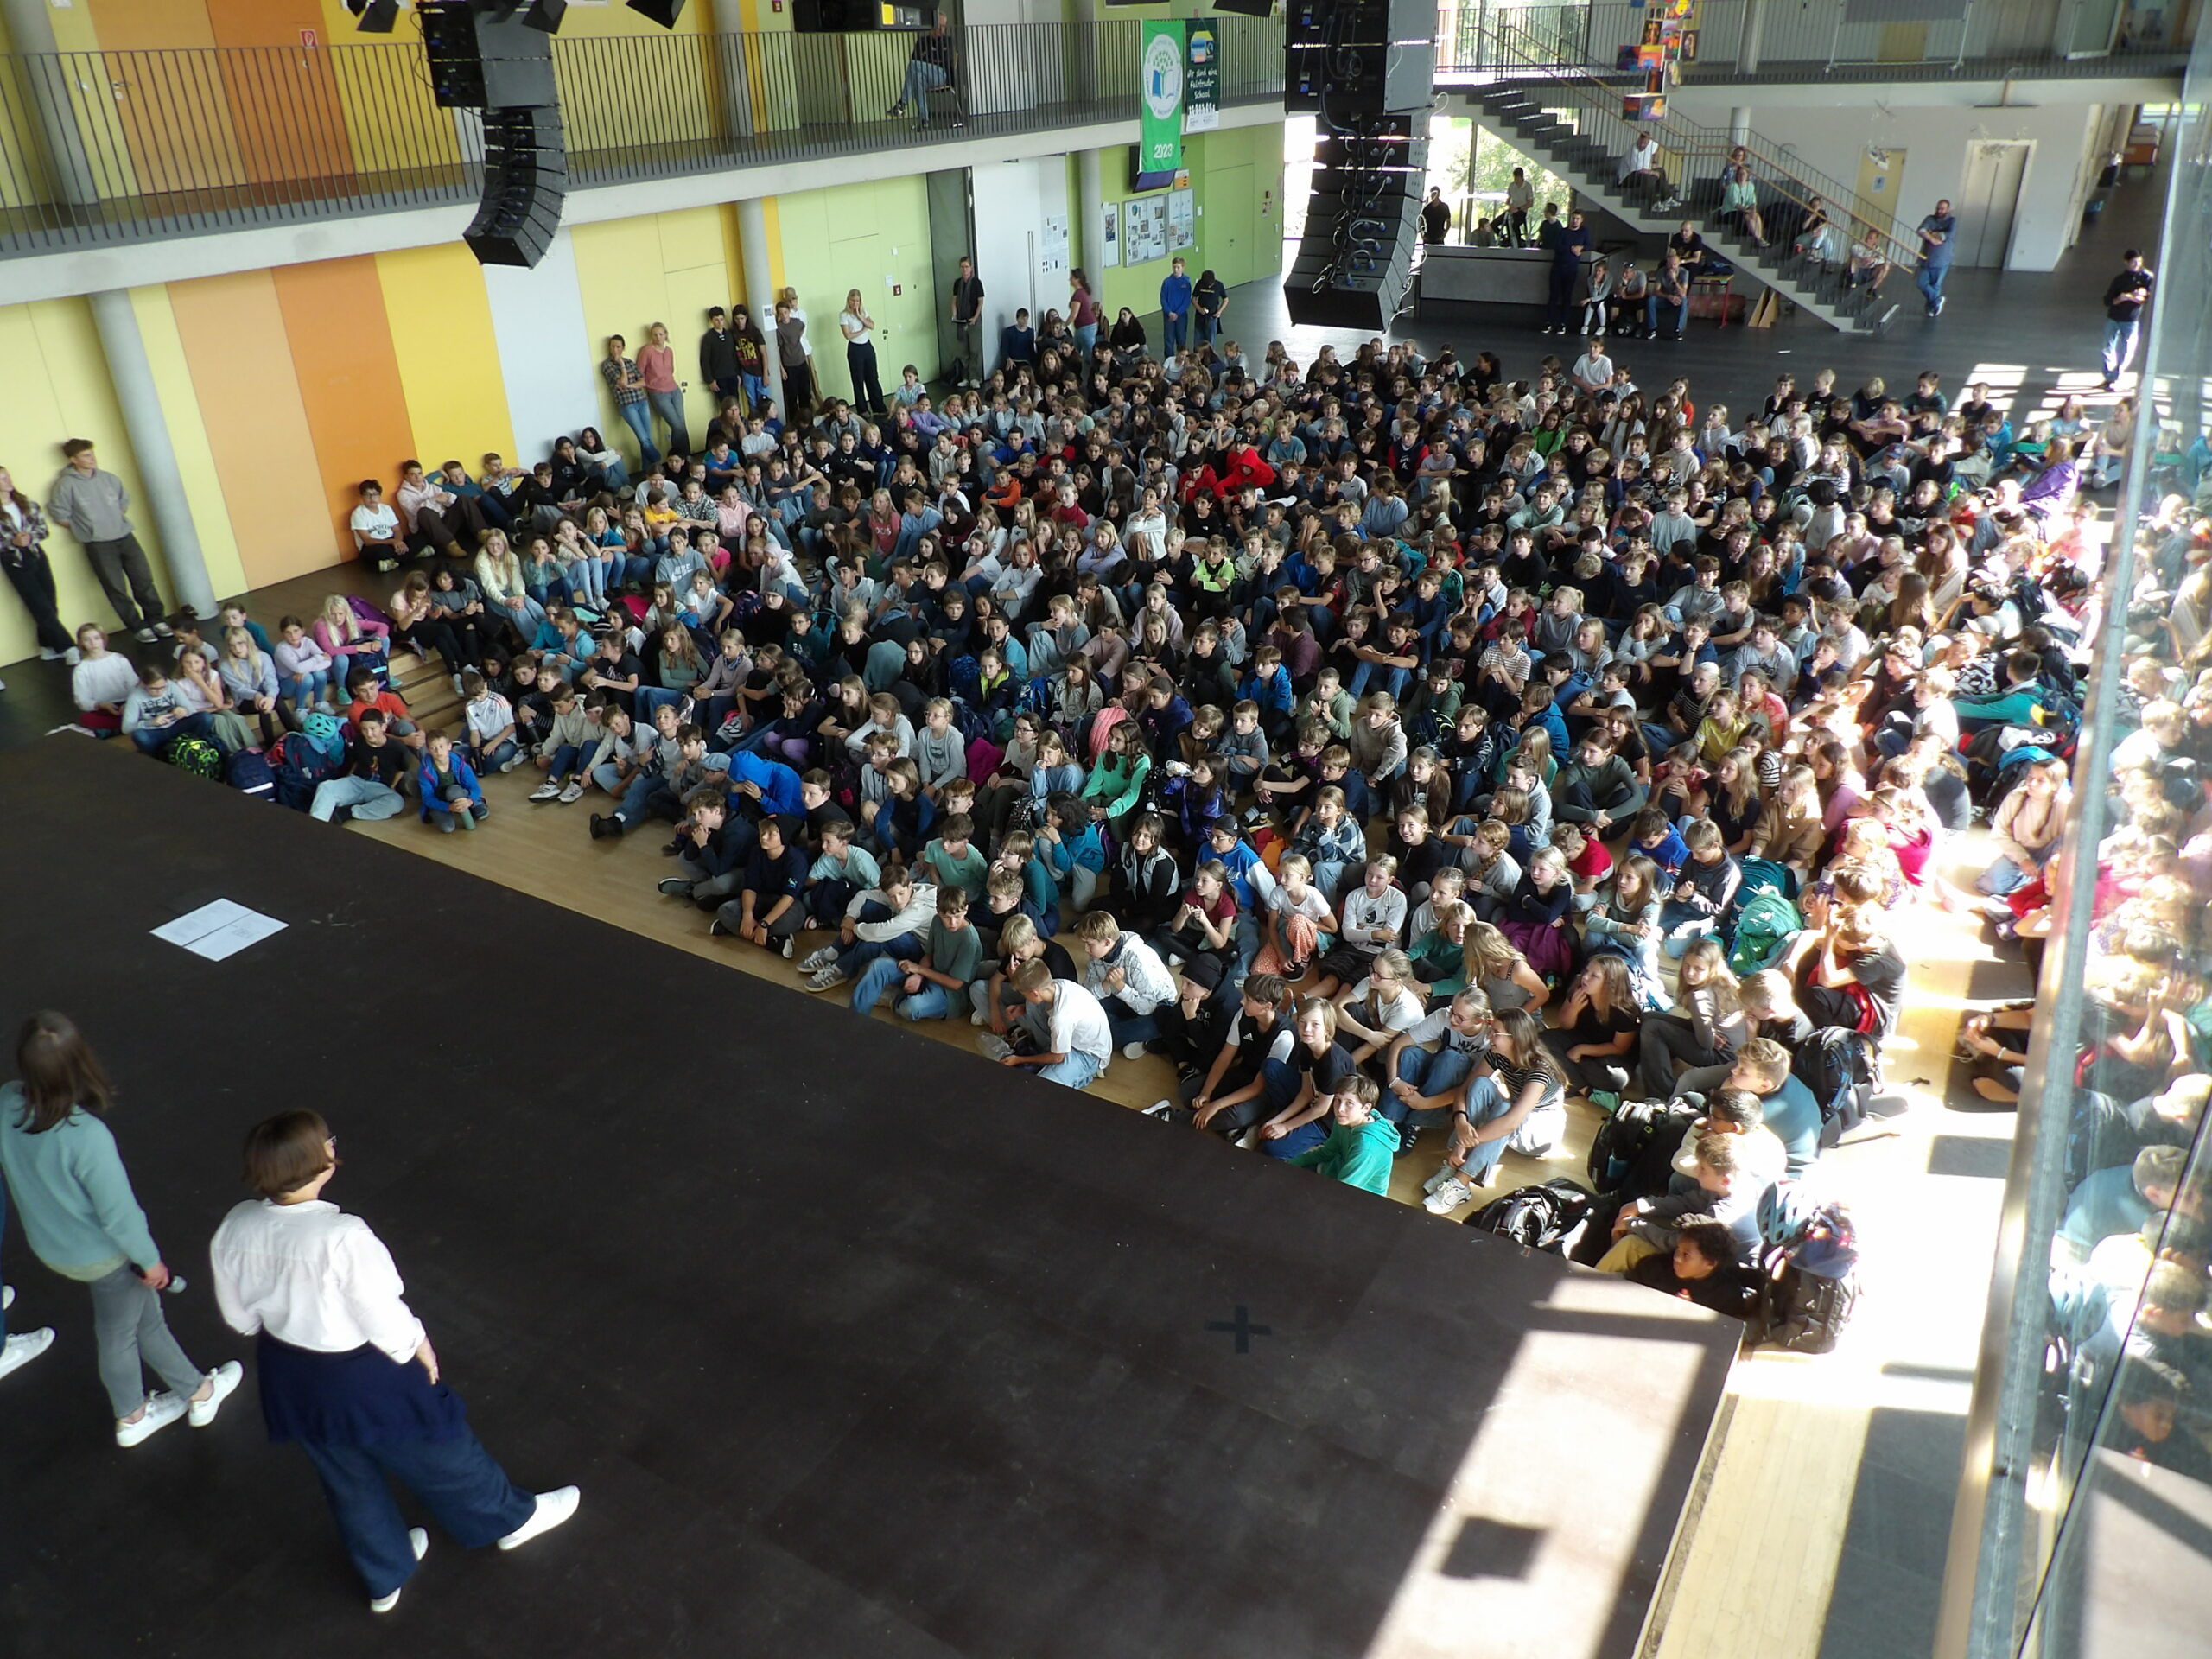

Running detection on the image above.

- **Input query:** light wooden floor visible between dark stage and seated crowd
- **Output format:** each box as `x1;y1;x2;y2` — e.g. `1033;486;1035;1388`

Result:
354;655;2029;1659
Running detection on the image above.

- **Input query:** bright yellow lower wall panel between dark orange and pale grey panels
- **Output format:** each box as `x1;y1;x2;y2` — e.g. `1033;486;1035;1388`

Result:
376;241;515;467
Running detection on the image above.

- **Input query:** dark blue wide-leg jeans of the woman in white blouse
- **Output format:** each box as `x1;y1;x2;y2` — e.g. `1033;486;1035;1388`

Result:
301;1433;537;1597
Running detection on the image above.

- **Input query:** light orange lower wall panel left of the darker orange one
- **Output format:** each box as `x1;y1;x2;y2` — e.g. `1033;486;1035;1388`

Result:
168;270;347;588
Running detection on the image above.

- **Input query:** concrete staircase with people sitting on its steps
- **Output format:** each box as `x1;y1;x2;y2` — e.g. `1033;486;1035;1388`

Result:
1466;78;1911;336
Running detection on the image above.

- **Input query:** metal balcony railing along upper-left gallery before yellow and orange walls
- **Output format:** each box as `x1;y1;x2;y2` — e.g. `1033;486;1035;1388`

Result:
0;16;1283;257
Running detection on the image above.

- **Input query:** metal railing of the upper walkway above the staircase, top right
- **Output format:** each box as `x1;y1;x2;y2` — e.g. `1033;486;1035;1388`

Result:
1435;0;2196;84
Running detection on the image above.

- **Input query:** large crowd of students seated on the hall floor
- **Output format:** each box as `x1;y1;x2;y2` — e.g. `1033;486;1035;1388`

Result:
52;318;2205;1344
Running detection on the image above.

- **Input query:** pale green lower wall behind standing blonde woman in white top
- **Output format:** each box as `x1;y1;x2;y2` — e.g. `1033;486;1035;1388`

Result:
777;173;938;398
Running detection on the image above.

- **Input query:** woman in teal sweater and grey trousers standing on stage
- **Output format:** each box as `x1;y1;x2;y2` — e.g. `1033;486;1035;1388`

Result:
0;1013;244;1446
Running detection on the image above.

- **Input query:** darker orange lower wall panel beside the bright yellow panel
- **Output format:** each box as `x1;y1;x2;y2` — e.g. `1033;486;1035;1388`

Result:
270;257;414;557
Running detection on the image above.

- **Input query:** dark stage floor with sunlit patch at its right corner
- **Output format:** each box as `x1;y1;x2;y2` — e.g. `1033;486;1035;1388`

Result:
0;739;1737;1659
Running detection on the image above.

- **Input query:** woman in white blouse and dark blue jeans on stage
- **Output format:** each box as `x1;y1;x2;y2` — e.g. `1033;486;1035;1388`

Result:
210;1110;577;1612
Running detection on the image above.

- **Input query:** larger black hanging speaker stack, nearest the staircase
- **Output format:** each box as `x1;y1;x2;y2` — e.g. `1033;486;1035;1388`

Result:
1283;0;1435;332
